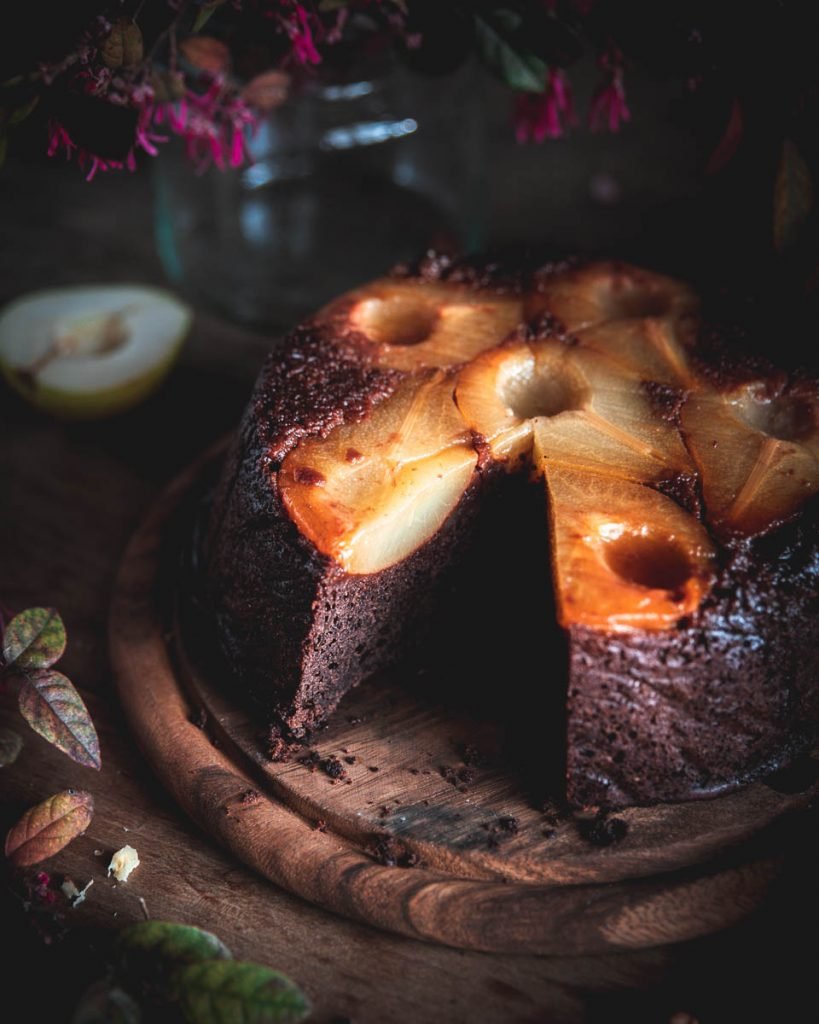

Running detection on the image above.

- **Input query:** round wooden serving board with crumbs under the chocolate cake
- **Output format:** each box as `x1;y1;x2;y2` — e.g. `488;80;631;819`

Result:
110;449;817;954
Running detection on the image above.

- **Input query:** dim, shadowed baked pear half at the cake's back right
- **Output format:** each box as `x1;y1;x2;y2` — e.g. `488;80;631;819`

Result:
527;262;699;333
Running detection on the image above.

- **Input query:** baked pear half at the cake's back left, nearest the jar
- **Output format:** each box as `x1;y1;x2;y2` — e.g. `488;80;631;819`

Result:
318;280;523;371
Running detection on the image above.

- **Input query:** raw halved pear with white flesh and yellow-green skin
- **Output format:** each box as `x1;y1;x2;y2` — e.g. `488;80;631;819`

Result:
0;285;191;419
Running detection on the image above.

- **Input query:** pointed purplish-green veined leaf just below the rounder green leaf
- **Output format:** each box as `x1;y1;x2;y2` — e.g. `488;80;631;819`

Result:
17;669;102;771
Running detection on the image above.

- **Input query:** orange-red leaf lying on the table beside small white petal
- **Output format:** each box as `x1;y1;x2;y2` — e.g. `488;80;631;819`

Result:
5;790;94;867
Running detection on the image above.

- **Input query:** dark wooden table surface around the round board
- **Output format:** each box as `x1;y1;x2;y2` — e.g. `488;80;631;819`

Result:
0;153;819;1024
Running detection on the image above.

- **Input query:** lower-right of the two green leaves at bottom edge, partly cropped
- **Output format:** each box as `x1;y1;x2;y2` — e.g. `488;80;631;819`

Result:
174;961;310;1024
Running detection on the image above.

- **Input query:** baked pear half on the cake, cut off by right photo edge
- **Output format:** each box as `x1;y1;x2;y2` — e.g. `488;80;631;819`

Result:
681;381;819;537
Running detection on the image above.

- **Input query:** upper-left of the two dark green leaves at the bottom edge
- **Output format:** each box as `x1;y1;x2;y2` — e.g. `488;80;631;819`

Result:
116;921;232;997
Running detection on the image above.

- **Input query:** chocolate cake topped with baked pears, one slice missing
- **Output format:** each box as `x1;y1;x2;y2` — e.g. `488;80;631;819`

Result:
205;257;819;807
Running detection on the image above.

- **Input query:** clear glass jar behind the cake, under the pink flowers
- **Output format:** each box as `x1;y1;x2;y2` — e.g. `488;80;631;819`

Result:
154;65;484;328
